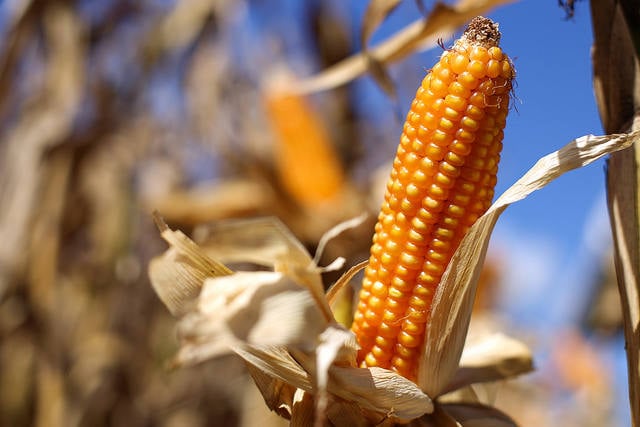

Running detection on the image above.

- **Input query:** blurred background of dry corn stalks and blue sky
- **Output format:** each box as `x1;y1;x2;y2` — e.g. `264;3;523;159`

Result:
0;0;629;427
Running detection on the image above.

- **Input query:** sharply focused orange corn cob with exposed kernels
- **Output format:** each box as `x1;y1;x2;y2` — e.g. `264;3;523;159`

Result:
352;17;515;381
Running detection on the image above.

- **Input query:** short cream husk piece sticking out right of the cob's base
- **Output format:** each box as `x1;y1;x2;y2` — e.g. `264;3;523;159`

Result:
448;333;533;390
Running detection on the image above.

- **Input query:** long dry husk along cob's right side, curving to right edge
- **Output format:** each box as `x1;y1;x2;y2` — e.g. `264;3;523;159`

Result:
418;132;640;396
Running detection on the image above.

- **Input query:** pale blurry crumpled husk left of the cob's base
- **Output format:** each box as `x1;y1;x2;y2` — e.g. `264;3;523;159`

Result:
177;272;326;363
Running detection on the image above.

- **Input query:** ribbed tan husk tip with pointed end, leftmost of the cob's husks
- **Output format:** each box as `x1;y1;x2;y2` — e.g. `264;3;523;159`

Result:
149;216;232;317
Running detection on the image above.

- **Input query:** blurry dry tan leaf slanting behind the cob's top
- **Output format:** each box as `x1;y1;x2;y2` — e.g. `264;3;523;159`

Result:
292;0;514;93
